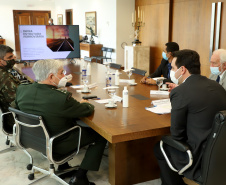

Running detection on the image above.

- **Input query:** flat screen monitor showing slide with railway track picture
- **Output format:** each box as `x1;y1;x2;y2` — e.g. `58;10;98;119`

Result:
19;25;80;61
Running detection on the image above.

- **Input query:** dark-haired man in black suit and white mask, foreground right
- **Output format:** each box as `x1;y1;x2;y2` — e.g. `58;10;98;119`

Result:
154;50;226;185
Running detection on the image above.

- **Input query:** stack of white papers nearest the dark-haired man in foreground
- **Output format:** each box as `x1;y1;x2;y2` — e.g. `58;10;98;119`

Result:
145;99;171;114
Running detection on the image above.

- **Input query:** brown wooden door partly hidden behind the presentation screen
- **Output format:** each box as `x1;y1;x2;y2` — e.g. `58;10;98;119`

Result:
13;10;51;59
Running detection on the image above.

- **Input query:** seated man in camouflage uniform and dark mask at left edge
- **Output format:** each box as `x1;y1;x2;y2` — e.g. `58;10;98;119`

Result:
0;45;20;129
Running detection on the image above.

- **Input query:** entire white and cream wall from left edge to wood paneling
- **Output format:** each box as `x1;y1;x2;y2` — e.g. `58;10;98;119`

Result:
0;0;135;64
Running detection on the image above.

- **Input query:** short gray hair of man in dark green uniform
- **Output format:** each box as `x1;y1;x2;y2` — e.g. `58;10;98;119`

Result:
32;59;64;82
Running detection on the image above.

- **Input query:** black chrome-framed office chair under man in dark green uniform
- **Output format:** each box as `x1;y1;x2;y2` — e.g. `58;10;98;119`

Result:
9;107;81;185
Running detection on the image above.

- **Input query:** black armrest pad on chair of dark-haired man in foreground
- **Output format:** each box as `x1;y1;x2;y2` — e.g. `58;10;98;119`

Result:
162;136;190;152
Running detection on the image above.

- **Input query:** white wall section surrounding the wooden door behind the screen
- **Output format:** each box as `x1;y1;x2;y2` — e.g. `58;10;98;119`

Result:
0;0;55;49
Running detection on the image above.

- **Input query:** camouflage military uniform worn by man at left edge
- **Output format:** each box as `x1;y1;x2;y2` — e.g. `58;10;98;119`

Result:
0;67;20;130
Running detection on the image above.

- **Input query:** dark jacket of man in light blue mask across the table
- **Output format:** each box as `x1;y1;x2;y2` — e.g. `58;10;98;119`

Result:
149;59;172;83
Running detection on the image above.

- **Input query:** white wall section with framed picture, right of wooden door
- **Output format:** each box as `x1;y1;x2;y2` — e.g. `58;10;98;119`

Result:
55;0;116;62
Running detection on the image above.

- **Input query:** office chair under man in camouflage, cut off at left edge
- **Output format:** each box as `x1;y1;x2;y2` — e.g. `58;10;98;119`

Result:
0;107;17;154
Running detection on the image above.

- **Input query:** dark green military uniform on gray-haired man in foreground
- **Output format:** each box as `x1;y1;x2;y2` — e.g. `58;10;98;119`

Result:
15;82;94;155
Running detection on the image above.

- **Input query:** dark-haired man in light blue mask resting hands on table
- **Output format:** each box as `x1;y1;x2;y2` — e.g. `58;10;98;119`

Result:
141;42;179;85
